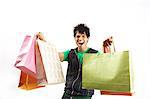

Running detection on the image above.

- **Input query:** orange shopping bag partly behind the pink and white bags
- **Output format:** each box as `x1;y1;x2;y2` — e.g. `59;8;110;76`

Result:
18;38;47;90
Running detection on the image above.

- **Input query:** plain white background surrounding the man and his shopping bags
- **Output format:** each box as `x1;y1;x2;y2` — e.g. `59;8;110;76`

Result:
0;0;150;99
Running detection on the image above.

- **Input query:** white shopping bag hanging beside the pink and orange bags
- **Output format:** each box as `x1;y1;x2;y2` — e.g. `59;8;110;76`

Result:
38;39;64;84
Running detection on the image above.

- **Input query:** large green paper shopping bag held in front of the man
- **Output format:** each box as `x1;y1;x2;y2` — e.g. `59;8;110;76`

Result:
82;51;133;92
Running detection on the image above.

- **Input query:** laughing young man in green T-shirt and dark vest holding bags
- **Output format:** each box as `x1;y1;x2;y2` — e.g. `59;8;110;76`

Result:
39;24;111;99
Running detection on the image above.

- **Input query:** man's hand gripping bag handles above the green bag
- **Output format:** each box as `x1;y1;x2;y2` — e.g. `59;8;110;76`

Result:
103;36;113;53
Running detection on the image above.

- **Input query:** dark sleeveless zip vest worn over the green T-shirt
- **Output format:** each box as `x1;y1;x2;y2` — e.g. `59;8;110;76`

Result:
65;48;98;96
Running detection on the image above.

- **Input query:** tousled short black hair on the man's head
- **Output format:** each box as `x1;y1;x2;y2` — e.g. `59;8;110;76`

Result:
73;24;90;37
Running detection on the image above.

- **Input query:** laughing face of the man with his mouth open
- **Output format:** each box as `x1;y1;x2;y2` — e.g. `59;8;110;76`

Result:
75;32;89;47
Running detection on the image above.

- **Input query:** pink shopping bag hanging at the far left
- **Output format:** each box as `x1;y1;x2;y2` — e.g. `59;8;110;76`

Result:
15;35;36;77
